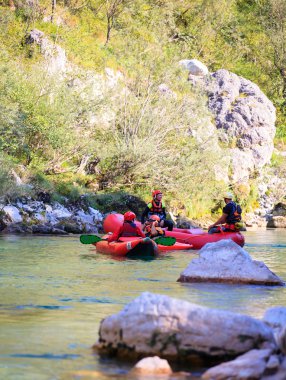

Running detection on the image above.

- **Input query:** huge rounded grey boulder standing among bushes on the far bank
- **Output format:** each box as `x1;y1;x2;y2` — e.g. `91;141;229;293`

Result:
206;70;276;181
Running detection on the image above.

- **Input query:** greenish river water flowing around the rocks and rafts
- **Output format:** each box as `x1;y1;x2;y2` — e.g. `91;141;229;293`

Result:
0;230;286;380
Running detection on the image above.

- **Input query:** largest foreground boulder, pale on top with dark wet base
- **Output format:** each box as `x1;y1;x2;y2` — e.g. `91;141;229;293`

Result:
95;292;275;361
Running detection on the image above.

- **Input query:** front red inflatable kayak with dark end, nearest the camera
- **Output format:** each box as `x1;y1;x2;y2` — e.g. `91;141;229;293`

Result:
93;235;158;258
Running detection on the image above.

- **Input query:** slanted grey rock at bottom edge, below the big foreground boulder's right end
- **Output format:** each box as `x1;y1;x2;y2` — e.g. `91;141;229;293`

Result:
202;349;272;380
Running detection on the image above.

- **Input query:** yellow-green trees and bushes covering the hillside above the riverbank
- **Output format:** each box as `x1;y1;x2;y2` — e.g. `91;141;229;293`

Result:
0;0;286;217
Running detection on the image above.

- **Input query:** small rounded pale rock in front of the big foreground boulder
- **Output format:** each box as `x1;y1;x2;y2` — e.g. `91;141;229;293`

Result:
132;356;172;375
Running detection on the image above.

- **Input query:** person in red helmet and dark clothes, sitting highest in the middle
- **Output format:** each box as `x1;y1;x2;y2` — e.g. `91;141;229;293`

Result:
141;190;174;231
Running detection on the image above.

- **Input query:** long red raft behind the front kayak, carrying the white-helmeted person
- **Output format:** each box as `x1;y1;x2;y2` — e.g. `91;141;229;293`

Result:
103;214;244;250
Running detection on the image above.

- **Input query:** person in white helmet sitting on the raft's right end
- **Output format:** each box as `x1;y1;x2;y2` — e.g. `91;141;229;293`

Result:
208;193;242;234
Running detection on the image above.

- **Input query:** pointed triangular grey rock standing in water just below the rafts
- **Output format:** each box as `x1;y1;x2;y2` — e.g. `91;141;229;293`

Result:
178;240;284;285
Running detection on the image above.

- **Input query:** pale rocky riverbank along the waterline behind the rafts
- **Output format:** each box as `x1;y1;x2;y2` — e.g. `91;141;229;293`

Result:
0;195;286;235
